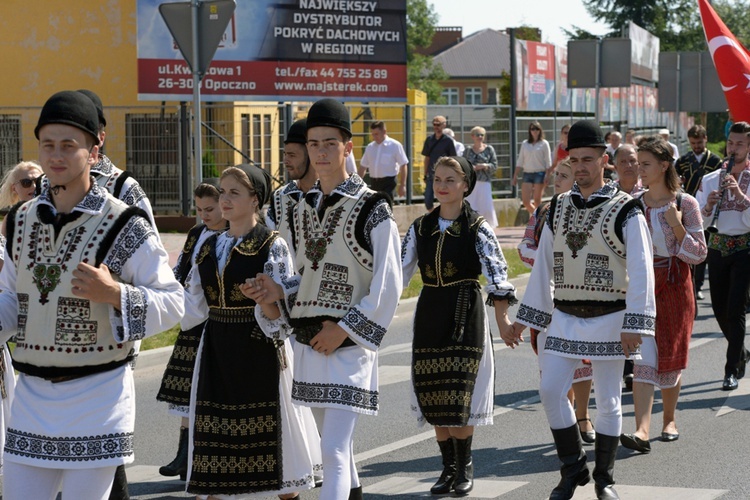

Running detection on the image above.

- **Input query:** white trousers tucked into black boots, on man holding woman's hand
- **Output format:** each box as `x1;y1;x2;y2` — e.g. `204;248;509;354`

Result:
539;350;625;436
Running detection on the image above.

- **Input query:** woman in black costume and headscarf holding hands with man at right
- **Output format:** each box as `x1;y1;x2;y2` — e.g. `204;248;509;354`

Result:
401;156;516;495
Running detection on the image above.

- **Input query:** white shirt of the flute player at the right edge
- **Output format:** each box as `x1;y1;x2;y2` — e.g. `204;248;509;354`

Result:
695;162;750;236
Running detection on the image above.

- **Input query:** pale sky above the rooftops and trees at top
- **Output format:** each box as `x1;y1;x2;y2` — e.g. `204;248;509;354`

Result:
428;0;609;46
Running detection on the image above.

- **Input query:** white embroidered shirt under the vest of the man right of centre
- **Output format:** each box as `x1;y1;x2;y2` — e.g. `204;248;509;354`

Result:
516;186;656;360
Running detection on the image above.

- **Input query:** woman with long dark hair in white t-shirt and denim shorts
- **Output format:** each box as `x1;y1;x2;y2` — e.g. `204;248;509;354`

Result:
510;121;552;215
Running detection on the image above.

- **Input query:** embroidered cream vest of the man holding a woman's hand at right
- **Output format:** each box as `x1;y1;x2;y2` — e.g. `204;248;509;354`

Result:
552;191;632;302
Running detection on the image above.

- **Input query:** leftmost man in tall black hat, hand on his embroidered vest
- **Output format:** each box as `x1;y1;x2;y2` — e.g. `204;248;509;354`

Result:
0;91;184;500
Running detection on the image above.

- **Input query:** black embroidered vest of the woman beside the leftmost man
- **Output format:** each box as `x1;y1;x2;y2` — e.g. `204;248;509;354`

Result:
195;224;279;323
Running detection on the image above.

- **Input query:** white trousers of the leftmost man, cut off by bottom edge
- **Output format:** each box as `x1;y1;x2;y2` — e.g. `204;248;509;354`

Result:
3;462;117;500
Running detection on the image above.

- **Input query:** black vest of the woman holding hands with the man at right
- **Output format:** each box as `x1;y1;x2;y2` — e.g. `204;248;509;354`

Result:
415;203;484;286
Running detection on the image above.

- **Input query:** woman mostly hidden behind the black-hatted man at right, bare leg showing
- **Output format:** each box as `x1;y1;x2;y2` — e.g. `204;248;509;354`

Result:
518;158;596;444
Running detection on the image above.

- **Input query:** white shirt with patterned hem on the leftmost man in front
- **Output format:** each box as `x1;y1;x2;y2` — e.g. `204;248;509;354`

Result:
0;185;185;469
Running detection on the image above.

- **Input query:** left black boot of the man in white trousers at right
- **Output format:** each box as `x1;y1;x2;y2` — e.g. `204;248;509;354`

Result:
549;424;598;500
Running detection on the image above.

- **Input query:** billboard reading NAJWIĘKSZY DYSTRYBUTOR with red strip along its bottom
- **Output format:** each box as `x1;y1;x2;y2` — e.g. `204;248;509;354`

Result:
136;0;406;101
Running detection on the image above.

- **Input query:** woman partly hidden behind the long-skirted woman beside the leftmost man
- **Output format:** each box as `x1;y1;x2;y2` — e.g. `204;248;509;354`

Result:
156;178;227;481
